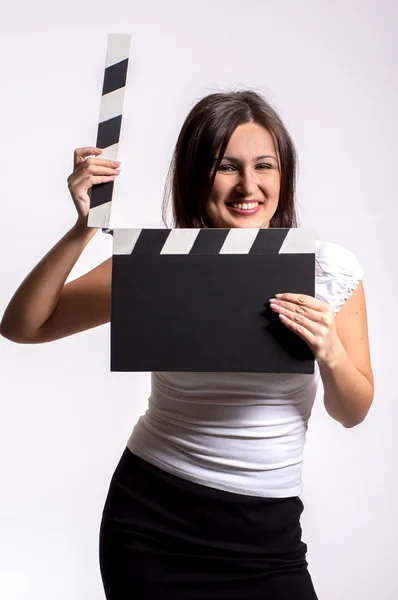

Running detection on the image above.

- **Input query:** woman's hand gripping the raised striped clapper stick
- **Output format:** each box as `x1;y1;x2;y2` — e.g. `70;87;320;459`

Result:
68;146;120;223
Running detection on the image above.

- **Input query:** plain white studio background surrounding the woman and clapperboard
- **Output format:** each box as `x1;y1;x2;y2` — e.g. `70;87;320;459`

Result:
0;0;398;600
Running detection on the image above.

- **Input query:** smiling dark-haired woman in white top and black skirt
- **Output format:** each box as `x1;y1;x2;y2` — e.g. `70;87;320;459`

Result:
1;91;373;600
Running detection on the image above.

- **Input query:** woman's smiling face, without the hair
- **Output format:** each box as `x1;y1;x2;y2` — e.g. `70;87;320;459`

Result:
206;123;280;228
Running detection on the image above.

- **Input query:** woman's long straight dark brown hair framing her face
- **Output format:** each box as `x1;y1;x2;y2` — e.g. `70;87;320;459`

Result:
162;90;297;228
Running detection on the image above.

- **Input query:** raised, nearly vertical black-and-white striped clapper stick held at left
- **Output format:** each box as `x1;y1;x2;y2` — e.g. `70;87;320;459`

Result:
88;34;131;228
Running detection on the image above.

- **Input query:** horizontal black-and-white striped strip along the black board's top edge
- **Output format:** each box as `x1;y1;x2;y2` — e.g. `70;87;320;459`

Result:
113;228;316;255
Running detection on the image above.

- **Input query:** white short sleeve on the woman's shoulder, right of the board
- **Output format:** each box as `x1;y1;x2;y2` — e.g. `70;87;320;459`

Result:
315;240;364;313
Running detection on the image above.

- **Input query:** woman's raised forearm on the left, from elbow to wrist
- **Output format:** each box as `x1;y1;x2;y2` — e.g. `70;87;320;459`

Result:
0;220;97;341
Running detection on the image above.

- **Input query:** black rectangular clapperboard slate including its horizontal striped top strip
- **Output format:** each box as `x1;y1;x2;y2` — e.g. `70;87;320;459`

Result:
111;228;316;373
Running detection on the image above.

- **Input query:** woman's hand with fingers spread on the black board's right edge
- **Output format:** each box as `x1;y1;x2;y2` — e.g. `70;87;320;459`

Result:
270;294;340;362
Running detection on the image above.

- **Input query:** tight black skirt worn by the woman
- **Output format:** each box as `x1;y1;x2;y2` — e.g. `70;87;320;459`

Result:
100;448;317;600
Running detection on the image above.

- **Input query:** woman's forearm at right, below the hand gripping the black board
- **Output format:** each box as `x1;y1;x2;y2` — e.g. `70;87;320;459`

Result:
319;343;373;427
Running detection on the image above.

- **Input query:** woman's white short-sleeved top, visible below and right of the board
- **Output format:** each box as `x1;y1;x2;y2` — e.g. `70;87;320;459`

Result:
127;241;363;498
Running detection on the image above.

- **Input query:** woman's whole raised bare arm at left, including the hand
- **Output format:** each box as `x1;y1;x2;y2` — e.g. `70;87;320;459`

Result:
0;148;120;344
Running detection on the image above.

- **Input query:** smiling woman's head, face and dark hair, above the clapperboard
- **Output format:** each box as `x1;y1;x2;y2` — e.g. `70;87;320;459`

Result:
163;90;297;228
